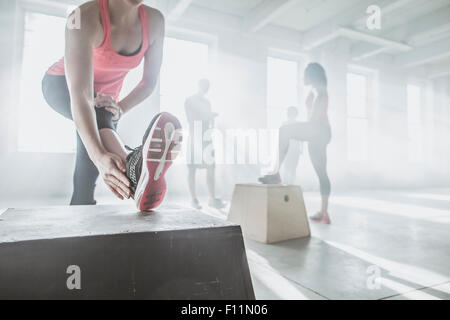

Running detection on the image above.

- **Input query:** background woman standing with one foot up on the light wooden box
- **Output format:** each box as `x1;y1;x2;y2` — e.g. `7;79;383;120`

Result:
259;63;331;223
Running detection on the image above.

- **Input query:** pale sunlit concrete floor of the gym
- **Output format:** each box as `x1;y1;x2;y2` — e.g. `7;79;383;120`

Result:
0;189;450;300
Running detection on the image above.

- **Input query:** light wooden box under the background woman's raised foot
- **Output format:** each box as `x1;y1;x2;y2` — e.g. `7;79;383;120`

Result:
228;184;311;243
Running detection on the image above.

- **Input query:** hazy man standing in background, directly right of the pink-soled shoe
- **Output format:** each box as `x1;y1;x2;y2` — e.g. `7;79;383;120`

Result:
184;79;225;209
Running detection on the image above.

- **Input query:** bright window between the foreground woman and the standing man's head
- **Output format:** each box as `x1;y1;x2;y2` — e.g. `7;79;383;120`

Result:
160;37;210;126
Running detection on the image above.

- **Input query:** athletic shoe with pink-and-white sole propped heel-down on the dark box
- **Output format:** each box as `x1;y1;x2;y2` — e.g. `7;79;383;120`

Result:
127;112;182;211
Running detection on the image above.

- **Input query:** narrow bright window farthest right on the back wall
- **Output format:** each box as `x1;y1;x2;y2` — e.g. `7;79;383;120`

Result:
407;85;424;163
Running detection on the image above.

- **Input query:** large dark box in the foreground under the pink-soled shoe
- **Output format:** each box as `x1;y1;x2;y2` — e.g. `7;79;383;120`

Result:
0;206;255;300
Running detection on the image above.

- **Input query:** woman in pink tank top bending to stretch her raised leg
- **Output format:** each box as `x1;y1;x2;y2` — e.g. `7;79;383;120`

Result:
42;0;181;211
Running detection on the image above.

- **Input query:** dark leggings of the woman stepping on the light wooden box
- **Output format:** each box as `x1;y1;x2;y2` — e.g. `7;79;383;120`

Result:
279;121;331;196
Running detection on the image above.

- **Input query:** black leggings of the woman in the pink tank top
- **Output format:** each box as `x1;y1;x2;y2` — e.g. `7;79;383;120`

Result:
42;74;117;205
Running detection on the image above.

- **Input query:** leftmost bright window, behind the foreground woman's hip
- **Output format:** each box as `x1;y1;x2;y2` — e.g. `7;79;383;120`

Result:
18;12;76;152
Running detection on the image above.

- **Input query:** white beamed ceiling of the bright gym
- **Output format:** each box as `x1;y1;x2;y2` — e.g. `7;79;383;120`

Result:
25;0;450;76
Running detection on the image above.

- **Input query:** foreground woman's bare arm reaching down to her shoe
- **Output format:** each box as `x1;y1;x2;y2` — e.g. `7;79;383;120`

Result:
65;3;130;199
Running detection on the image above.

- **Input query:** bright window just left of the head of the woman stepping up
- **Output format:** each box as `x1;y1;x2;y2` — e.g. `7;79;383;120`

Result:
267;57;299;128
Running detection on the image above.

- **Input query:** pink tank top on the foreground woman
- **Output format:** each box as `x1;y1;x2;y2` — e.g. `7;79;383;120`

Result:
47;0;149;100
